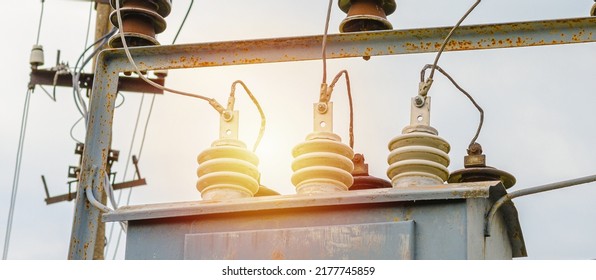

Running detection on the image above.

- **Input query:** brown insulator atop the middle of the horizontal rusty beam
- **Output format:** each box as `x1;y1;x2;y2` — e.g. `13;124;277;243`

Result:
338;0;397;33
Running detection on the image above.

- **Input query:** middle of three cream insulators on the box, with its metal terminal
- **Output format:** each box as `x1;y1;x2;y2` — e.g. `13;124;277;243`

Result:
292;102;354;194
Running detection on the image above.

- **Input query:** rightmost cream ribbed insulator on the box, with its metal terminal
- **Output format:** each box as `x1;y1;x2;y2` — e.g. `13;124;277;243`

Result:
387;96;450;188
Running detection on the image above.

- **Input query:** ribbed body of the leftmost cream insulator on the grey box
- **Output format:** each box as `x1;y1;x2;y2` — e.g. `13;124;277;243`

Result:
197;139;259;200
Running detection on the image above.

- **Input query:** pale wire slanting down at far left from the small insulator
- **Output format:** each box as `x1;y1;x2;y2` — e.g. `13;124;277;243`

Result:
2;89;32;260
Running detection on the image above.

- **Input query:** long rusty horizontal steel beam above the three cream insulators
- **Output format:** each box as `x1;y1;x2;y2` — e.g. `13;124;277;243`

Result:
103;17;596;72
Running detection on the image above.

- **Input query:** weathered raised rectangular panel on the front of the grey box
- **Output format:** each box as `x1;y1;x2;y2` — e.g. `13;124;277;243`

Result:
184;221;415;260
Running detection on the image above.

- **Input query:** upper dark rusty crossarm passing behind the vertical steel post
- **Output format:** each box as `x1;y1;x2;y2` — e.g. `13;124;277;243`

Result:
29;69;165;94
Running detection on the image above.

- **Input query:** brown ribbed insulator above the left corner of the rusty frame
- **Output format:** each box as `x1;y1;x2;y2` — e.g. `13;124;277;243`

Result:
109;0;172;48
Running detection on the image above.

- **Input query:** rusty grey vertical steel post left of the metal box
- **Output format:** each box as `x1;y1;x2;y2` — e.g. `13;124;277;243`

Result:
68;52;118;260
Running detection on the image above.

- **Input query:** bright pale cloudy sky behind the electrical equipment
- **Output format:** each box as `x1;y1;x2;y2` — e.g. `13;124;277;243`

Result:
0;0;596;259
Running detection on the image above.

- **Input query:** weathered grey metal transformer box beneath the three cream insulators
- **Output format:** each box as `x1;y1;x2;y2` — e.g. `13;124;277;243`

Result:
104;182;527;259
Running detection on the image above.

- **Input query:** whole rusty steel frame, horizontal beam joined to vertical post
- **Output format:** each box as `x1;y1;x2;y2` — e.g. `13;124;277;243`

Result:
69;17;596;259
